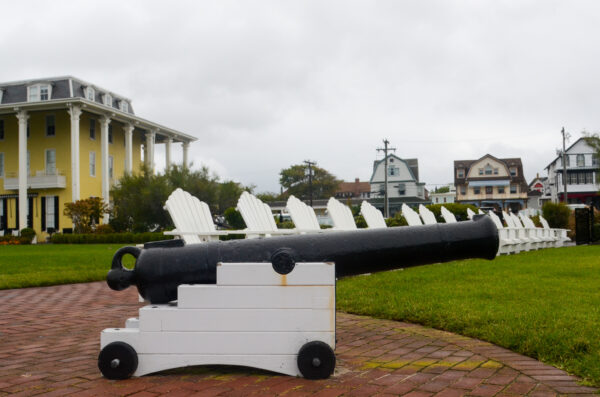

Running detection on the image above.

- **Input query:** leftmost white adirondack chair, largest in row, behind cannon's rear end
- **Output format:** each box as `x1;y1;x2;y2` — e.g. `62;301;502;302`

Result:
164;188;228;244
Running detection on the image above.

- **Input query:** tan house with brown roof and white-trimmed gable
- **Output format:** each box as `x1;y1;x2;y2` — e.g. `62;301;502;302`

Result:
454;154;529;212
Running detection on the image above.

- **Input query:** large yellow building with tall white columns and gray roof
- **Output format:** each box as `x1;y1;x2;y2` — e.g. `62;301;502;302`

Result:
0;76;196;238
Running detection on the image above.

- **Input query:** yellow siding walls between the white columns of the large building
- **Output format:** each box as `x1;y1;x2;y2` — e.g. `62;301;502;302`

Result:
0;109;142;239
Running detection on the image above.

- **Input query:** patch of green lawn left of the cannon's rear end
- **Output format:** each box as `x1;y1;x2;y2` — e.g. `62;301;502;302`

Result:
0;244;129;289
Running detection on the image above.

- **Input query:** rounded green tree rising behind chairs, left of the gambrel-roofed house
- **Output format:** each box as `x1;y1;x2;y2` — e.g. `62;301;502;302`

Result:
279;164;342;199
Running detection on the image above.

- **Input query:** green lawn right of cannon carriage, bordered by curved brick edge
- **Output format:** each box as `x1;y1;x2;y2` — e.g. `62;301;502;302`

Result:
337;246;600;386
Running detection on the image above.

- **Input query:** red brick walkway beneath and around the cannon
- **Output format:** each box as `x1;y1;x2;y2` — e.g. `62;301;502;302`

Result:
0;282;597;397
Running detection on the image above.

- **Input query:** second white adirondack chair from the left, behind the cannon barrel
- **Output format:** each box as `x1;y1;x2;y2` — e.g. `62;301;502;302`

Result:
237;192;297;238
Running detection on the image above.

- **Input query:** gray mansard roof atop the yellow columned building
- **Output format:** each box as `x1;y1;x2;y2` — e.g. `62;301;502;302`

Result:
0;76;135;114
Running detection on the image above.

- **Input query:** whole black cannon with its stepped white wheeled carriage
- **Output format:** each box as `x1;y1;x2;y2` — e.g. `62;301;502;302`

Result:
98;216;499;379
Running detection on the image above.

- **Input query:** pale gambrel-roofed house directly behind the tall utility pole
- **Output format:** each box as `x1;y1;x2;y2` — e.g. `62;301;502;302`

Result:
369;154;428;215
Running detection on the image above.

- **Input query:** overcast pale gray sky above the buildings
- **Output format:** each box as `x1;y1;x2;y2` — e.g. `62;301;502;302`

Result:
0;0;600;192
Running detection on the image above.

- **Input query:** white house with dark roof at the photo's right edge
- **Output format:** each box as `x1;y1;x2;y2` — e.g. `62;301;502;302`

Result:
545;138;600;209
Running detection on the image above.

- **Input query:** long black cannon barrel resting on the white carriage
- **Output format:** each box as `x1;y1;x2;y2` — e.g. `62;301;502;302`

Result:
107;216;498;303
